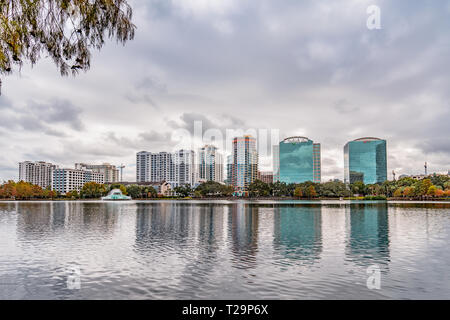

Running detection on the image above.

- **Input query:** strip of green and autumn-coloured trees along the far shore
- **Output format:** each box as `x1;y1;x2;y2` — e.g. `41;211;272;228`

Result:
0;175;450;201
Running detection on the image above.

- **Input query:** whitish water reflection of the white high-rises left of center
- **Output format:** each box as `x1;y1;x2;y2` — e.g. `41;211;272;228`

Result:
135;202;226;290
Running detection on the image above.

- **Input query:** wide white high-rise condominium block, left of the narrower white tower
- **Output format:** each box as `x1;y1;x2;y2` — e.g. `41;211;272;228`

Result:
136;150;196;187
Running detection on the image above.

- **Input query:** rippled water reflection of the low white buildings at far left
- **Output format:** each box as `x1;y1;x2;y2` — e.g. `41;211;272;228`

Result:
17;201;118;237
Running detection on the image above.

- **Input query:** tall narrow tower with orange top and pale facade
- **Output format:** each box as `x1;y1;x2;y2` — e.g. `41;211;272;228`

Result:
231;135;258;192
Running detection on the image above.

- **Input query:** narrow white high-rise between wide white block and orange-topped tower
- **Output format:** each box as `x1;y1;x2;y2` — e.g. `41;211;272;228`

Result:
198;145;223;182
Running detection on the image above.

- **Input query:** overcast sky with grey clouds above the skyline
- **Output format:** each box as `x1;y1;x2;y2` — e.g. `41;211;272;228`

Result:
0;0;450;181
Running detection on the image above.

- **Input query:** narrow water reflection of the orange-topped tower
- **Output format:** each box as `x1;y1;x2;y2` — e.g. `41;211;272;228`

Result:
228;203;259;269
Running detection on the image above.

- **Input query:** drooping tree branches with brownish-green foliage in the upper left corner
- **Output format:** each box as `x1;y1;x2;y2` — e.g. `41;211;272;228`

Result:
0;0;136;92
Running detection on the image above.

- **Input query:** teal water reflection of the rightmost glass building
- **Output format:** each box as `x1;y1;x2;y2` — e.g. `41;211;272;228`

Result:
345;203;390;265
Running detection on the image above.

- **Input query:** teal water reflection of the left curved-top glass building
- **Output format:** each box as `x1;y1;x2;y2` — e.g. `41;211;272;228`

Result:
274;204;322;262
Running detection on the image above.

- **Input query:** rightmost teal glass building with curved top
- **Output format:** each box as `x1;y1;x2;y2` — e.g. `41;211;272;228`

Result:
344;137;387;184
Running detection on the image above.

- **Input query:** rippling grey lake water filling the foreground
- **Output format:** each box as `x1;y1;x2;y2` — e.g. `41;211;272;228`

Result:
0;201;450;299
